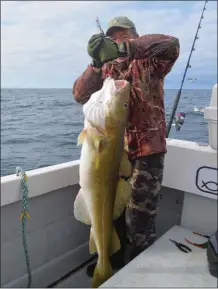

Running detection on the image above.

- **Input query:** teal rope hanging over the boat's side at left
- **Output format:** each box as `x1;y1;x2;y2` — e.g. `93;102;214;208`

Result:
16;167;32;288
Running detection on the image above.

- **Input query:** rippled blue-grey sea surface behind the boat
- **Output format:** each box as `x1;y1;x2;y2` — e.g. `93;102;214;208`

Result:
1;89;211;176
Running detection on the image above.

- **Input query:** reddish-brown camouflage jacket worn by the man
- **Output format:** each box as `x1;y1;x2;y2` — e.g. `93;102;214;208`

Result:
73;34;180;159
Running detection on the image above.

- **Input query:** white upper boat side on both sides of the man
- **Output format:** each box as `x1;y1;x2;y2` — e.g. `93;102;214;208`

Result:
1;139;217;206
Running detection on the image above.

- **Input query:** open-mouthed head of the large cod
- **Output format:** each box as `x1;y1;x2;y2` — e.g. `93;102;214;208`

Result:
104;77;130;125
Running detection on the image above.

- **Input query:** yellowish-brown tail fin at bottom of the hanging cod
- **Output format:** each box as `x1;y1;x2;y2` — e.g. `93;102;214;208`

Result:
92;260;113;288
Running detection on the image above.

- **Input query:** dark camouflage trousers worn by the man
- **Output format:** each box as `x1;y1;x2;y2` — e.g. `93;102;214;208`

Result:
112;153;165;263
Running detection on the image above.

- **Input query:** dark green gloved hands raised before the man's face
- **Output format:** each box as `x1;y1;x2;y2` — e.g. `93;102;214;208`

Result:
88;34;133;68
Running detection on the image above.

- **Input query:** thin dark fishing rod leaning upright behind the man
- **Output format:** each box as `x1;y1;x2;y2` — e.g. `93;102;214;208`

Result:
166;0;208;137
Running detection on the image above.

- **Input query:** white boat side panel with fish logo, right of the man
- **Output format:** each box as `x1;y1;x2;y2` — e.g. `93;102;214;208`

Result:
163;139;217;200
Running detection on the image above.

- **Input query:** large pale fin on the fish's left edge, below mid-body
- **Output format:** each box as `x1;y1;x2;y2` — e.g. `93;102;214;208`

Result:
74;189;91;225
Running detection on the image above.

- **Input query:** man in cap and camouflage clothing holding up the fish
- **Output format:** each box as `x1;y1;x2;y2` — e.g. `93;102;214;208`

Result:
73;16;180;276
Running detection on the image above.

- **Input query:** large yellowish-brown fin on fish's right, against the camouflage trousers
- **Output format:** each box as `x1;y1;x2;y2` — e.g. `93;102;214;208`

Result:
113;178;132;220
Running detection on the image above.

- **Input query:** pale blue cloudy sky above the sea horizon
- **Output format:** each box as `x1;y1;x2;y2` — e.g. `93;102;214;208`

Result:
1;1;217;89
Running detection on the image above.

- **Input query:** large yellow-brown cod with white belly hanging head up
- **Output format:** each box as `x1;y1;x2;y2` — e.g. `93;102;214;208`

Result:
74;77;131;287
